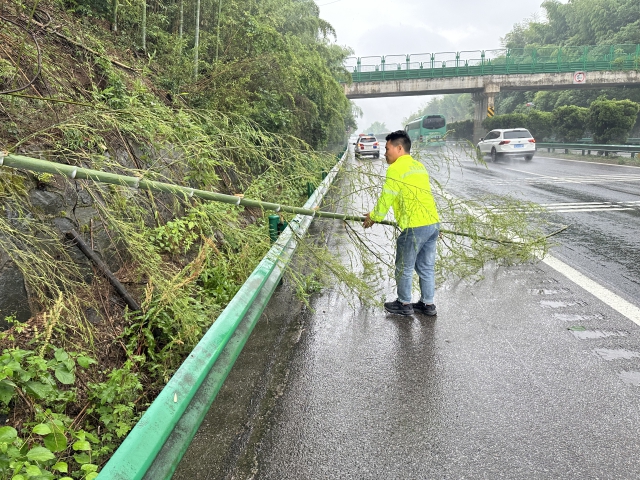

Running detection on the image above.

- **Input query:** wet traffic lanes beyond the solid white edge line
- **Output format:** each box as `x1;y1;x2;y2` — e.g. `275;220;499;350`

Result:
434;151;640;304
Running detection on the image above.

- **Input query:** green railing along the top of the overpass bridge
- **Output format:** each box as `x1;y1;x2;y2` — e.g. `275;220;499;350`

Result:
345;44;640;82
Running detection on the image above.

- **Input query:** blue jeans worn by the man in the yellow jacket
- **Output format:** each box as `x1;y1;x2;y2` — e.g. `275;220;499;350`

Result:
396;223;440;304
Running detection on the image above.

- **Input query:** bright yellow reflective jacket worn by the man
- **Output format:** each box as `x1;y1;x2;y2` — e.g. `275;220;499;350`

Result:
370;155;440;230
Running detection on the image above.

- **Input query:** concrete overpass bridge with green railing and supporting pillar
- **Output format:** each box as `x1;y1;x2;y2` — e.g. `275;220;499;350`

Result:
344;45;640;140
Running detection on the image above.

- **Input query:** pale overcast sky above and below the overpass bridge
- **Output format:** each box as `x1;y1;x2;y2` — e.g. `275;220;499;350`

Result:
316;0;566;130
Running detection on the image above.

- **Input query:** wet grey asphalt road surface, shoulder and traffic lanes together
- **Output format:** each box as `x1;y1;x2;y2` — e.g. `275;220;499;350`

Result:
174;148;640;479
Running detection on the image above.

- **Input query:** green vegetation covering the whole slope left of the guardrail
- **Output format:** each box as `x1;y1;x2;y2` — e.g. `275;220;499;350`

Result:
0;0;355;479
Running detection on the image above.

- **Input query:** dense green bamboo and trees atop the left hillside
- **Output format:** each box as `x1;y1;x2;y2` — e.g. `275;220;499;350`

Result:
63;0;356;148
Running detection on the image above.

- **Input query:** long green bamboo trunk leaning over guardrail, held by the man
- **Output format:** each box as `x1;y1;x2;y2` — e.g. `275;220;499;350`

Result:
0;152;396;226
